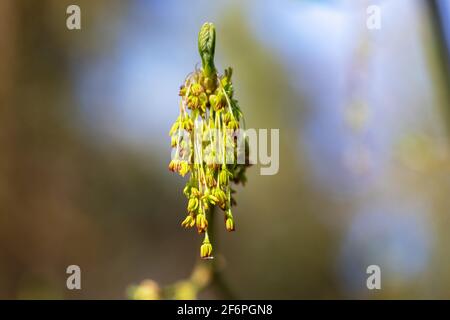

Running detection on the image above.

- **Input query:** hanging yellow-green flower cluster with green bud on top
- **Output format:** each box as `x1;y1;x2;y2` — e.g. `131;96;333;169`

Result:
169;23;248;259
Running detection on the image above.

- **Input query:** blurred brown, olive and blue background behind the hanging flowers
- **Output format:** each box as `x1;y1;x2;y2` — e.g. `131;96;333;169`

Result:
0;0;450;299
